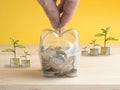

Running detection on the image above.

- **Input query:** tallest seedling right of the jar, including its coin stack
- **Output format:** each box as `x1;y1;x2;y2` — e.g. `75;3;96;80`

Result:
95;27;118;55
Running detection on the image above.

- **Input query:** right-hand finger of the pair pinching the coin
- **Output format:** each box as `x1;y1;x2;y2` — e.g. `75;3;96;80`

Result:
60;0;79;28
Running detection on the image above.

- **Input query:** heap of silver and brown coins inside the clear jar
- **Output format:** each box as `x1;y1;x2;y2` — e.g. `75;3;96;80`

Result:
41;46;77;77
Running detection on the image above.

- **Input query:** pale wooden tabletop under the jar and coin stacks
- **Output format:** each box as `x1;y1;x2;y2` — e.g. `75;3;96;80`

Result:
0;45;120;90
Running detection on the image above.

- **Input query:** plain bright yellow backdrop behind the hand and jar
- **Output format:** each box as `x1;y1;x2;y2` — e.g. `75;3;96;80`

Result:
0;0;120;44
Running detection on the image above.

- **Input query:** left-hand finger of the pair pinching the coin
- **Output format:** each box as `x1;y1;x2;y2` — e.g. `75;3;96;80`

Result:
38;0;60;29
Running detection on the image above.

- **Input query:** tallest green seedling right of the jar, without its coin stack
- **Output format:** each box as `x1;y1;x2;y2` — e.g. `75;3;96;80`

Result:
95;27;118;47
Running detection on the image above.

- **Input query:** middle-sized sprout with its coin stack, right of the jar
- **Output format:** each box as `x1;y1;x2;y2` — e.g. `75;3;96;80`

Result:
89;39;99;56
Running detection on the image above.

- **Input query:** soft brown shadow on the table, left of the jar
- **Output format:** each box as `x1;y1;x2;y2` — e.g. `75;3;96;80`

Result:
4;64;42;78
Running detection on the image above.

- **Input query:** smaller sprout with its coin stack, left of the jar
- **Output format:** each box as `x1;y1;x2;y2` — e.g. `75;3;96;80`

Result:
20;51;31;67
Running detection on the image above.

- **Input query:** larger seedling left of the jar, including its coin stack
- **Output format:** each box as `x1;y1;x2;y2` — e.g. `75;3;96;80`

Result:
2;38;25;67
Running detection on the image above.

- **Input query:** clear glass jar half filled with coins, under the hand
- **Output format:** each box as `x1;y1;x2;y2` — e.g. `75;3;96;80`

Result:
40;29;80;77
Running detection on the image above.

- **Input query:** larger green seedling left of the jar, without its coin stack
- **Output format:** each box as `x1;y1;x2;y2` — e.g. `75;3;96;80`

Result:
2;38;25;58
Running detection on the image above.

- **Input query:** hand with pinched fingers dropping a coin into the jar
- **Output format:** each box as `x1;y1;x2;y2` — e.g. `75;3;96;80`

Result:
38;0;79;29
